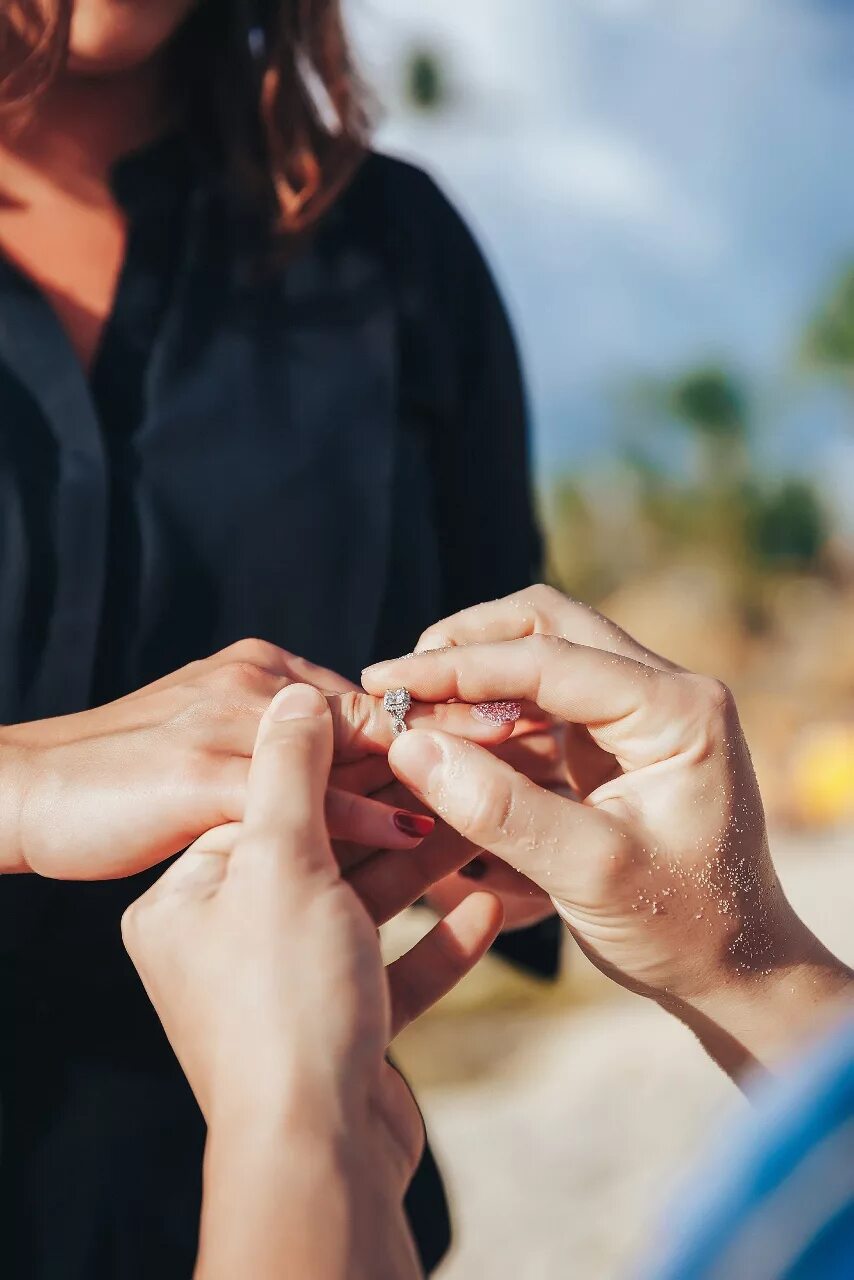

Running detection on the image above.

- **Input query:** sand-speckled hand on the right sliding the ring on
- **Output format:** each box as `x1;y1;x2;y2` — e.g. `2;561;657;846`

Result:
364;588;850;1070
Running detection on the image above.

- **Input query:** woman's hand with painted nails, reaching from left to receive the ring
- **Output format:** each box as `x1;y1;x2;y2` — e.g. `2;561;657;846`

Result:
0;640;507;879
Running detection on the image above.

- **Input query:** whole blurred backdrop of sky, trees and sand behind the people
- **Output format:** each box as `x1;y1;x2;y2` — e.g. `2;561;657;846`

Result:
347;0;854;1280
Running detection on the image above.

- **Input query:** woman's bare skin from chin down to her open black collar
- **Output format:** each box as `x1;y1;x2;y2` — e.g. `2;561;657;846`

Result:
0;0;195;370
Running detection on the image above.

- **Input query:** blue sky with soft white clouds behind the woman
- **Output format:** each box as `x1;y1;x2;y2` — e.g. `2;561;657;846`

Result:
350;0;854;519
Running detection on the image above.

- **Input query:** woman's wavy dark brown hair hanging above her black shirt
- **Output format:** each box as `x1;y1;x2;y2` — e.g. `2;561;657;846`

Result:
0;0;370;234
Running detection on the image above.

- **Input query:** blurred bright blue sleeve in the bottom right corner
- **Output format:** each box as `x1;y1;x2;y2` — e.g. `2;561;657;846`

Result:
641;1016;854;1280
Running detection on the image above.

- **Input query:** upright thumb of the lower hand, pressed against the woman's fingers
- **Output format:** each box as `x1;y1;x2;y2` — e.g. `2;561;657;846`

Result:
240;685;338;876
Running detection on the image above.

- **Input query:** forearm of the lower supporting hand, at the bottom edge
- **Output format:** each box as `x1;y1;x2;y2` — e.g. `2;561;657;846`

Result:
195;1119;420;1280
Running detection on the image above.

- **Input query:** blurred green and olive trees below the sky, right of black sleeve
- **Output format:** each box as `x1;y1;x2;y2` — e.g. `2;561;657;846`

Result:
547;288;839;630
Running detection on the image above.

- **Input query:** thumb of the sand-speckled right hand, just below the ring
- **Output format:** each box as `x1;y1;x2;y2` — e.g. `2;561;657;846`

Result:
389;732;620;893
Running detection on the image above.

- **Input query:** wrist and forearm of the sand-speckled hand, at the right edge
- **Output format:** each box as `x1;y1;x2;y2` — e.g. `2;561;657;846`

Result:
662;913;854;1085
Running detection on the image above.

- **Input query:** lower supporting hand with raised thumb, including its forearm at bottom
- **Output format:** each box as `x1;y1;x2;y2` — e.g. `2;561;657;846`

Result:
123;685;501;1280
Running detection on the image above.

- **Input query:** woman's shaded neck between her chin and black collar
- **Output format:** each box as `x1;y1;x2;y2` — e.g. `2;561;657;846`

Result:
0;58;172;198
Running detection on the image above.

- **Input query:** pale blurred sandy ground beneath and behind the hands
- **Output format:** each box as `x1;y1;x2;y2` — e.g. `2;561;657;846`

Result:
389;832;854;1280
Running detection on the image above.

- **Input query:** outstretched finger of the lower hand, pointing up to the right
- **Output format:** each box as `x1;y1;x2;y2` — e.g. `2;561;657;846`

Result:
387;893;503;1038
